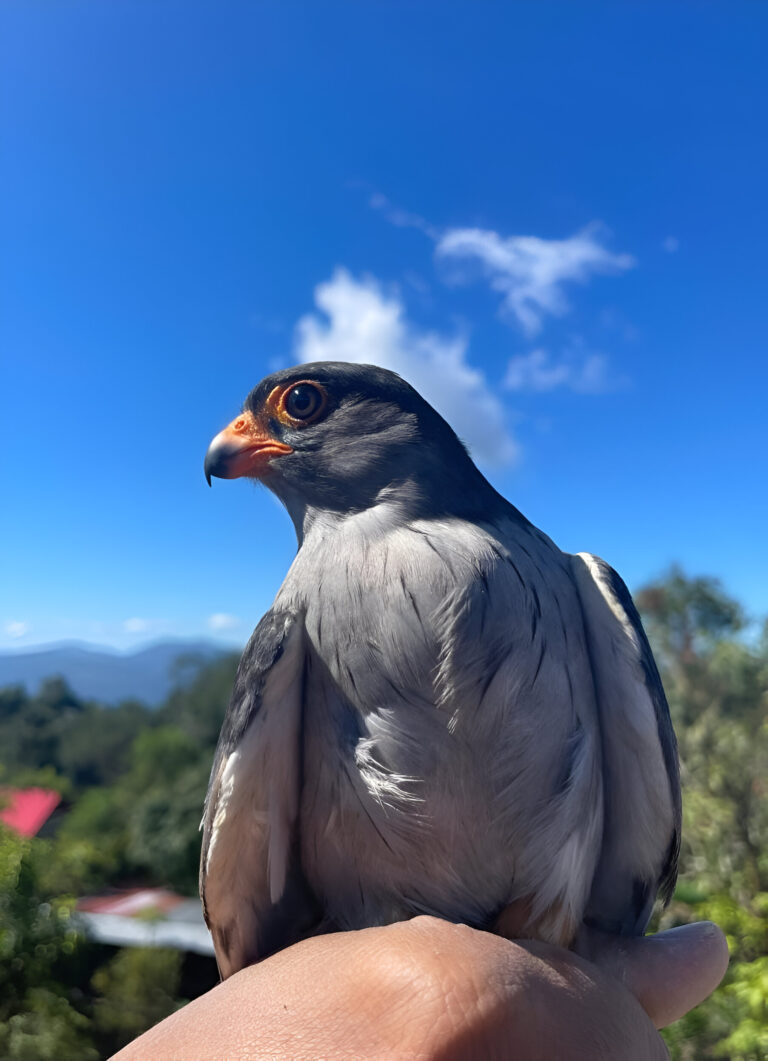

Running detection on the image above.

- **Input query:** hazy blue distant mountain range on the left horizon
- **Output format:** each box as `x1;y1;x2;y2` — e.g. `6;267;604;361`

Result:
0;641;234;707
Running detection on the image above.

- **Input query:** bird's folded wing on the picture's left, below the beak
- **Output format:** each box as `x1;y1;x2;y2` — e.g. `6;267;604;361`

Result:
199;611;317;977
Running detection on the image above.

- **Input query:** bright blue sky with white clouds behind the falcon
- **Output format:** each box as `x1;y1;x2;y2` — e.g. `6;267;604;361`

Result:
0;0;768;648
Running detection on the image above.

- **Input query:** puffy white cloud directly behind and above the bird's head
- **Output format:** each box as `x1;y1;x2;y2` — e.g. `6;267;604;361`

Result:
296;268;518;465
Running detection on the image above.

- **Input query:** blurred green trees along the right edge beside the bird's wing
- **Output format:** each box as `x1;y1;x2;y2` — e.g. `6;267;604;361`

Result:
636;569;768;1061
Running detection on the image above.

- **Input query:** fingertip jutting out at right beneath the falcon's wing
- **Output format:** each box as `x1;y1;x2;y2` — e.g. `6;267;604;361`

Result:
578;921;728;1028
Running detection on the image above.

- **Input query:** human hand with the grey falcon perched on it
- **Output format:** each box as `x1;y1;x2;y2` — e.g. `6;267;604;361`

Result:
115;918;728;1061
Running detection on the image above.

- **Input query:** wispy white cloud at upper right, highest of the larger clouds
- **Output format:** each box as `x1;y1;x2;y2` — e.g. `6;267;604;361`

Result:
435;225;634;334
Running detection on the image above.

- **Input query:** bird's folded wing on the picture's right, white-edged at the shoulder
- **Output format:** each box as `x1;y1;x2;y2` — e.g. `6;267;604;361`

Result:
572;553;681;935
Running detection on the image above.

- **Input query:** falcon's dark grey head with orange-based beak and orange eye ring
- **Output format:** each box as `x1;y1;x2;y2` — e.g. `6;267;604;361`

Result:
205;361;495;537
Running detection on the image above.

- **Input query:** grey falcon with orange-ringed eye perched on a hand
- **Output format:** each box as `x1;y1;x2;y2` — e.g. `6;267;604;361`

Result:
200;362;681;977
